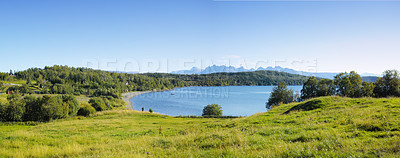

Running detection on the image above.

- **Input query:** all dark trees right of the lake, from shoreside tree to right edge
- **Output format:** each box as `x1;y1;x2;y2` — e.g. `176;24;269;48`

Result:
266;70;400;109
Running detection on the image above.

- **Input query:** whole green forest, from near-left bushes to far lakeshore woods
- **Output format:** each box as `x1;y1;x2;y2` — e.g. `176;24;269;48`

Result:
0;65;307;122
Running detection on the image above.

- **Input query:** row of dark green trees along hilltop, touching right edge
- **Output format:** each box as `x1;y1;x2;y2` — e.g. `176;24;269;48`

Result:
301;70;400;100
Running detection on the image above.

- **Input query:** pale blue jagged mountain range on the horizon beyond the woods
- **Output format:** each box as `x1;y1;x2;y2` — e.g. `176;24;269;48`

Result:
171;65;379;82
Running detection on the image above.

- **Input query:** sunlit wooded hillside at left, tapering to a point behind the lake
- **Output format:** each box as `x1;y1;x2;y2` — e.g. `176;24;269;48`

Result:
9;65;174;98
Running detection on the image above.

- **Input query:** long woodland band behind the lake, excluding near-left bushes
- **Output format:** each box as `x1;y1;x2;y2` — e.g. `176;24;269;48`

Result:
0;65;307;98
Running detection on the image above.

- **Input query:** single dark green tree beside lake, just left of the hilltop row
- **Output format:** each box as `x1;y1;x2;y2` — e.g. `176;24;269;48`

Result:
266;82;295;109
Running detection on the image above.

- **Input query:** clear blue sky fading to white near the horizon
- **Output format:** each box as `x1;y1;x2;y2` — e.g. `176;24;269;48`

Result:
0;0;400;74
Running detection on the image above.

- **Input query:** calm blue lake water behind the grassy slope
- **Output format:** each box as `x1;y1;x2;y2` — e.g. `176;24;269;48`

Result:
131;86;302;116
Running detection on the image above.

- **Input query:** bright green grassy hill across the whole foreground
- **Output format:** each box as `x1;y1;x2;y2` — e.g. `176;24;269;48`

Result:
0;97;400;157
